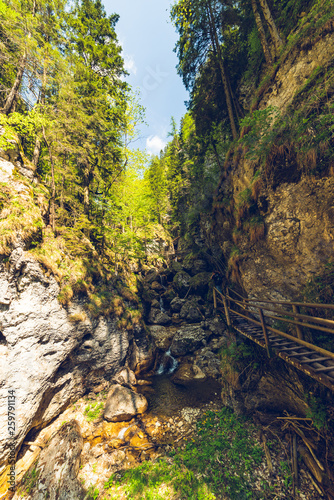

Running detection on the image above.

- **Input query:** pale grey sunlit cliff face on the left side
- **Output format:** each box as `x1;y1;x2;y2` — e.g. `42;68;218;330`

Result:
0;160;130;463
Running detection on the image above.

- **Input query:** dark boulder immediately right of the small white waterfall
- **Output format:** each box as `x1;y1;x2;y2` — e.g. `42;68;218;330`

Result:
170;325;211;356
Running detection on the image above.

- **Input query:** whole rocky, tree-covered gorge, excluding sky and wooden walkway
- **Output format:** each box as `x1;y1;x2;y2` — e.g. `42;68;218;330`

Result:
0;0;334;500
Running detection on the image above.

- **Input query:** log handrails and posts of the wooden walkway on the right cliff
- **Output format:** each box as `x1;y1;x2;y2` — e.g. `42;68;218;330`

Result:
213;288;334;388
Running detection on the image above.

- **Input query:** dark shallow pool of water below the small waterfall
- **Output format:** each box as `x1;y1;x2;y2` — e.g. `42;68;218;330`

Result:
140;375;221;417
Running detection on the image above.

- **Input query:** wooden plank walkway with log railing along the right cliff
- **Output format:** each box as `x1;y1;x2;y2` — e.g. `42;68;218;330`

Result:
214;290;334;392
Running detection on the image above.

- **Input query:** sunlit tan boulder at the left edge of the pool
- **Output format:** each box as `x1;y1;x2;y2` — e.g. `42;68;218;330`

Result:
103;384;148;422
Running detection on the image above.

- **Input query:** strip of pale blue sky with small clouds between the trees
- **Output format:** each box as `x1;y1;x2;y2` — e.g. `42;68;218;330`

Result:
104;0;188;154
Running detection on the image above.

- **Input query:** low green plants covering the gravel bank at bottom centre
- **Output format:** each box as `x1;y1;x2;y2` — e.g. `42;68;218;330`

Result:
105;408;263;500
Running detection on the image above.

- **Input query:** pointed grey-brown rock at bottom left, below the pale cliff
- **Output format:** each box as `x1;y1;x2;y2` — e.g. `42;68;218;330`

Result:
14;420;85;500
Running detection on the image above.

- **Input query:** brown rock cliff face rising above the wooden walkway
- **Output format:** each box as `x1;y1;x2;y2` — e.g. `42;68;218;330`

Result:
201;27;334;299
